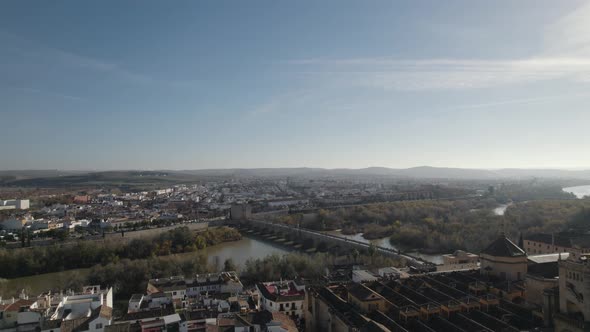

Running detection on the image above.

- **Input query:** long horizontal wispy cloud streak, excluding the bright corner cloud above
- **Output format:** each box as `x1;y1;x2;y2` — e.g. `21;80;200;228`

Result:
294;57;590;91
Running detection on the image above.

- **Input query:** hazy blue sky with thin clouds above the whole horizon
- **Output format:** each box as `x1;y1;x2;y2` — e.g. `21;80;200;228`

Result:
0;0;590;169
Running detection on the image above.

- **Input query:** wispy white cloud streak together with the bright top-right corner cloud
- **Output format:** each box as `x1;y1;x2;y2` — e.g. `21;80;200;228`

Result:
287;5;590;91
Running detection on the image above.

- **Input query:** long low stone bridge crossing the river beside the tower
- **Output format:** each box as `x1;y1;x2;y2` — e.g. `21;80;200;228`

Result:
232;219;436;272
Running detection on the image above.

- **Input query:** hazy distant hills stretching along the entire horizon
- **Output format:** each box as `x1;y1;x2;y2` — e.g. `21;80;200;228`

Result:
0;166;590;187
